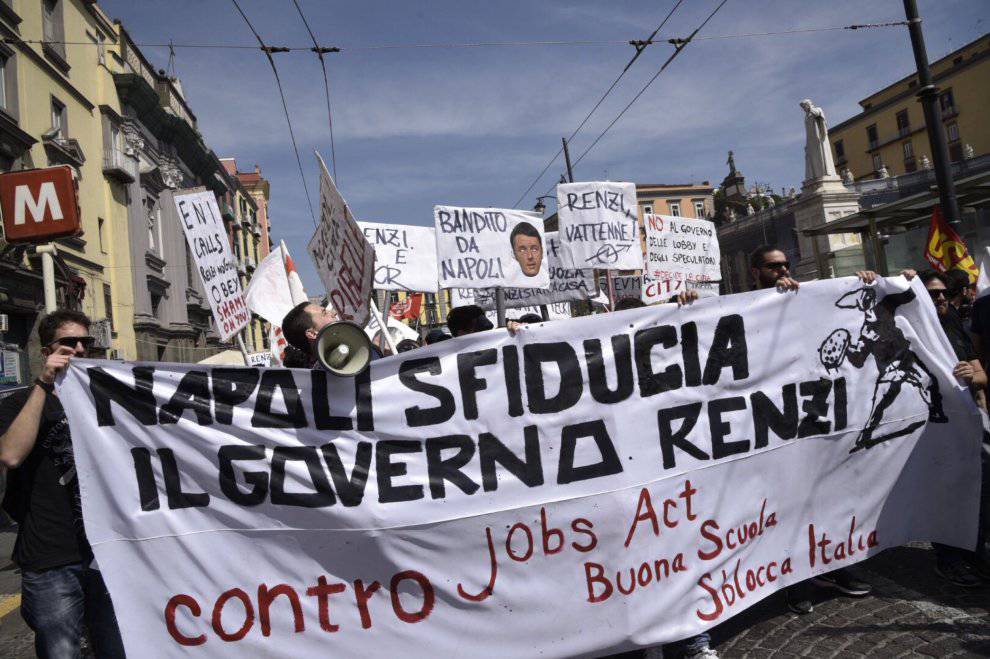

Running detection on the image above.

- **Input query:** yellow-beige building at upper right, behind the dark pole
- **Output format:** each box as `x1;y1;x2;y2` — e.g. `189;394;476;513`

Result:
829;34;990;180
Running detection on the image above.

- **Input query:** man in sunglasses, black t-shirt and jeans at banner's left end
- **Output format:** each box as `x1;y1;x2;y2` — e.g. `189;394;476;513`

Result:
0;311;124;659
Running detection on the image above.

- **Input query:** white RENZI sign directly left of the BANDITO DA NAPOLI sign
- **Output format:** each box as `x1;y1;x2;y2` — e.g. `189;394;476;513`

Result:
358;222;439;293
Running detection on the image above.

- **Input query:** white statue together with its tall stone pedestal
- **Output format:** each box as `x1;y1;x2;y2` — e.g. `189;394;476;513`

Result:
794;99;864;278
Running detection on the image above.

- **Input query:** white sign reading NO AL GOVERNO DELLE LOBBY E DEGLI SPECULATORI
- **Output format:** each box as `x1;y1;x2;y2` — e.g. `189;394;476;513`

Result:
642;215;722;304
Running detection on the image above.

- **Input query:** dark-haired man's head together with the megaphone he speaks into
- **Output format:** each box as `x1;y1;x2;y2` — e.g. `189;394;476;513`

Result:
282;302;372;376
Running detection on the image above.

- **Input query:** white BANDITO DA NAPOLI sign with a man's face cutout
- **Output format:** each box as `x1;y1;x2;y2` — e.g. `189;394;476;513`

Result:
433;206;550;288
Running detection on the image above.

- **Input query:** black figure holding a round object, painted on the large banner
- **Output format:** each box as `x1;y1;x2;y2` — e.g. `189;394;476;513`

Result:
818;286;948;453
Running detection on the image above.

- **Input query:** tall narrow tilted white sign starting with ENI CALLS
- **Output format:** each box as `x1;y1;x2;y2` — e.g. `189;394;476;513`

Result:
173;190;251;341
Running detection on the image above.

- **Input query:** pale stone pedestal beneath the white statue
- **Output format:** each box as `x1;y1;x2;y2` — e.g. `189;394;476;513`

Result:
792;176;864;280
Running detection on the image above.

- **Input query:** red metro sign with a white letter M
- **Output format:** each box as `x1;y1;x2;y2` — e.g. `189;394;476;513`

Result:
0;166;80;243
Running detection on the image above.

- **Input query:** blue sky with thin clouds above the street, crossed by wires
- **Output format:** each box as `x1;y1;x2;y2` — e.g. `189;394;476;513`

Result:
100;0;990;295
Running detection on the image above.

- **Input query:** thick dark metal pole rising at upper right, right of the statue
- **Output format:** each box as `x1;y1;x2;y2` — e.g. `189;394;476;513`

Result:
904;0;960;224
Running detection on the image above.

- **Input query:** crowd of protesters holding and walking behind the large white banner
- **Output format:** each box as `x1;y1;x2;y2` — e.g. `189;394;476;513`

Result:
0;245;990;658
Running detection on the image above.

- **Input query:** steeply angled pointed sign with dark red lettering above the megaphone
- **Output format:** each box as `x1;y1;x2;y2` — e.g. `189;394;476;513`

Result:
308;155;375;324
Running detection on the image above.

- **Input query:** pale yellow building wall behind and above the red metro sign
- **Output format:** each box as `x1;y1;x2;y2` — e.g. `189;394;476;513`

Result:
12;0;134;356
